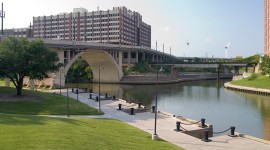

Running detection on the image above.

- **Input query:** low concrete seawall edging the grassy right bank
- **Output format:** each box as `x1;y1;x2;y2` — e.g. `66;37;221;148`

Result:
224;82;270;96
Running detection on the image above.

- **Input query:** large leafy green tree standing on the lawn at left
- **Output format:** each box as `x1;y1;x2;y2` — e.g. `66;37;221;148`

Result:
0;37;62;95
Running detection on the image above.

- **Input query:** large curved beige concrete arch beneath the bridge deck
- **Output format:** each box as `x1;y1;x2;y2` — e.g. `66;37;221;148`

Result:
54;49;123;86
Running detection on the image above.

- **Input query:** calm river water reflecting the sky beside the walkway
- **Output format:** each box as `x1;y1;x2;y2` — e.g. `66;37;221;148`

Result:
73;81;270;140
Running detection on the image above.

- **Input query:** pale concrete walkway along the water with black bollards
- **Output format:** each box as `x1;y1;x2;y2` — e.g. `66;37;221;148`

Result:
47;91;270;150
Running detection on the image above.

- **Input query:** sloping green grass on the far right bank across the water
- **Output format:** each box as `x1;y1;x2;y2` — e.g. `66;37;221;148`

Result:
231;74;270;89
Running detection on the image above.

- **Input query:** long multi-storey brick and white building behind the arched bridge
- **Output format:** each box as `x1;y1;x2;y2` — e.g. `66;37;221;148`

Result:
33;7;151;47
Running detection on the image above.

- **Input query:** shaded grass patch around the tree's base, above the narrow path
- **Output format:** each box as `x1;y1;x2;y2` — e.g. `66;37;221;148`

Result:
0;87;101;115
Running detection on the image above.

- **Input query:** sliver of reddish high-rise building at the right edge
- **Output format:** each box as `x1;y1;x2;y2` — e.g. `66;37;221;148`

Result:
264;0;270;56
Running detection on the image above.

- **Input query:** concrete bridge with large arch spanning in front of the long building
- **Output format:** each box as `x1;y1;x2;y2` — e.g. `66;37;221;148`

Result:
29;38;177;86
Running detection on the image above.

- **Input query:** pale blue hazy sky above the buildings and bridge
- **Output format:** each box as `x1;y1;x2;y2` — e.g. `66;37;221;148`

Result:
2;0;264;58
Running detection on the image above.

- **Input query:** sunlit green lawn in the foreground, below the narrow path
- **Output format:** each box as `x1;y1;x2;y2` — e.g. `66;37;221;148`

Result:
0;114;181;150
